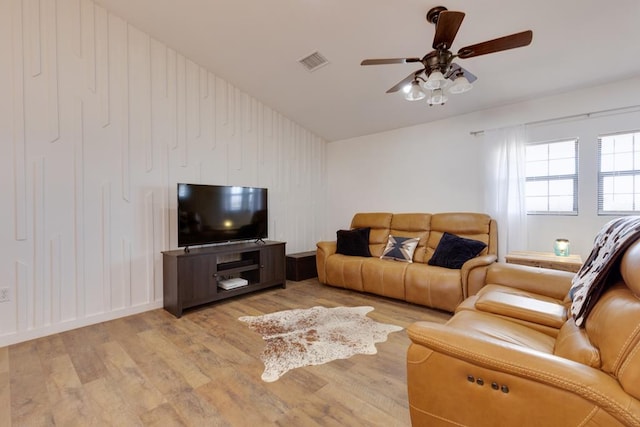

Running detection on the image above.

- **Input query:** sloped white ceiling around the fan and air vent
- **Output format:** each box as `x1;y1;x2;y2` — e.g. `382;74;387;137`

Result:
96;0;640;141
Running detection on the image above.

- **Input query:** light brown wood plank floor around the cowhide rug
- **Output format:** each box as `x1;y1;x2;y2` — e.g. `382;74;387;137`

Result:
0;279;449;427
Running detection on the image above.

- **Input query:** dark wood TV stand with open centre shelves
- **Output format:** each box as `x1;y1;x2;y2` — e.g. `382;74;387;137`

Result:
162;240;287;317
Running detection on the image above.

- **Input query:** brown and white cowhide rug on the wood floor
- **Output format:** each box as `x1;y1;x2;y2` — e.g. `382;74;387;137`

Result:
238;306;403;382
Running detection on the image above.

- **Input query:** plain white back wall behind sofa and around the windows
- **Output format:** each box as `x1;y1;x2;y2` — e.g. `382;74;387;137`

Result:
324;78;640;259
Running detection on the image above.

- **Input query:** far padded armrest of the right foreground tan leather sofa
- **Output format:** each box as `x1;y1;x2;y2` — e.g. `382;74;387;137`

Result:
486;262;575;301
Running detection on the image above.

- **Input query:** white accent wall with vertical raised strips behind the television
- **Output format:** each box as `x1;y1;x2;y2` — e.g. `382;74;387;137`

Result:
0;0;326;346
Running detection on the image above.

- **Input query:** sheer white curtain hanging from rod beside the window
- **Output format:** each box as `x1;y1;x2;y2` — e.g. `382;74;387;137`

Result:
484;125;527;261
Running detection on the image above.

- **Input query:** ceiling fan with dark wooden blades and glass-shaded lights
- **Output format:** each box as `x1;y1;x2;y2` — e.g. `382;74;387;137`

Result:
360;6;533;105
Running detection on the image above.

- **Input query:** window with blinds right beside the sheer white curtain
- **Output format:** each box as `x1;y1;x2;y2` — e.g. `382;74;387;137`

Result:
525;139;578;215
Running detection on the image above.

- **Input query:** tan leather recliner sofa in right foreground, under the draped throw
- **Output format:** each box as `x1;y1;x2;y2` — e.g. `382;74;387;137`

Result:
407;240;640;427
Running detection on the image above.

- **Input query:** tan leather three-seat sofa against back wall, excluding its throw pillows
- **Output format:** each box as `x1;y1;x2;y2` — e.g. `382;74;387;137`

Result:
316;213;498;312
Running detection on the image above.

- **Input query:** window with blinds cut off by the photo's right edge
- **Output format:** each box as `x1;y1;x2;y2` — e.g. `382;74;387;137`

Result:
598;131;640;215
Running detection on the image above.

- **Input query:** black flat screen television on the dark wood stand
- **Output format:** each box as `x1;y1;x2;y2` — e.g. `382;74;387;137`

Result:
178;183;268;247
